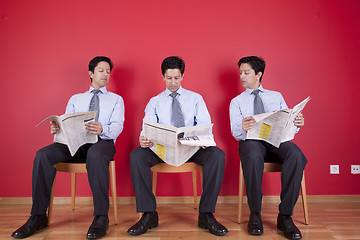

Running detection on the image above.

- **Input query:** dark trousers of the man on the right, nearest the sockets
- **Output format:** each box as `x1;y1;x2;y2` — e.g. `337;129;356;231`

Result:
239;140;307;215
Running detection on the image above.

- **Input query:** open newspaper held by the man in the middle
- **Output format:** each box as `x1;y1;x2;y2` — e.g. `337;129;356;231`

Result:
143;119;216;167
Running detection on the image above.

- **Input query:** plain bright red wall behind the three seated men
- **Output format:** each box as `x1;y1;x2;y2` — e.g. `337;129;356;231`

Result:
0;0;360;197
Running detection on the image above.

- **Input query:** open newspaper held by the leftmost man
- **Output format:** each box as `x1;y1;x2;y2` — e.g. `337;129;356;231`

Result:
36;111;98;156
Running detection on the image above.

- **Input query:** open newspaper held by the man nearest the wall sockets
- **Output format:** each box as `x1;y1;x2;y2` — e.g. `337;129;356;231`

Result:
246;96;310;148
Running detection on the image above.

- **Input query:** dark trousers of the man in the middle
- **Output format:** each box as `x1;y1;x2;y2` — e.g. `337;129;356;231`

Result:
130;147;225;213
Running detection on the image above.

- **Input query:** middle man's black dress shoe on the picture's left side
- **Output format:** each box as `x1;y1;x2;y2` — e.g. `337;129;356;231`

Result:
128;212;159;235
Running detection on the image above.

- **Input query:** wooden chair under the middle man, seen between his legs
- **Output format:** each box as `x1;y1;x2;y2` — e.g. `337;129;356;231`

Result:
151;162;203;209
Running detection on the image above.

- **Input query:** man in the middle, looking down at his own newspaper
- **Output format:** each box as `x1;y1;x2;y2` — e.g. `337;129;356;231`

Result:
128;56;228;236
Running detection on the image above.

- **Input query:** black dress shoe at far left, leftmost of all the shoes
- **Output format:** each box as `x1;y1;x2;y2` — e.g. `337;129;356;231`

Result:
11;214;47;238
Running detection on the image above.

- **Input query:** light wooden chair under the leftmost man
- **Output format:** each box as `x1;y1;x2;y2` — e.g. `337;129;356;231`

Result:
48;160;118;225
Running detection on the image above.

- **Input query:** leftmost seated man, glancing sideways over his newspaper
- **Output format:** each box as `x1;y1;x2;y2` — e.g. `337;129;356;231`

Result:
11;56;124;239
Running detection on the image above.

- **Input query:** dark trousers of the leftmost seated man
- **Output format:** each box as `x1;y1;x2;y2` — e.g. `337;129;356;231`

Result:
31;139;115;216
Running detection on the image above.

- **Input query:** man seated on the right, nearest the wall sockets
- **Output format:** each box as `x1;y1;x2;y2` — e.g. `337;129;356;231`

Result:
230;56;307;239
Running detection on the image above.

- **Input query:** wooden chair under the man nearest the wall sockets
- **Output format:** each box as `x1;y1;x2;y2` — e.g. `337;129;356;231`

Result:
238;162;309;225
